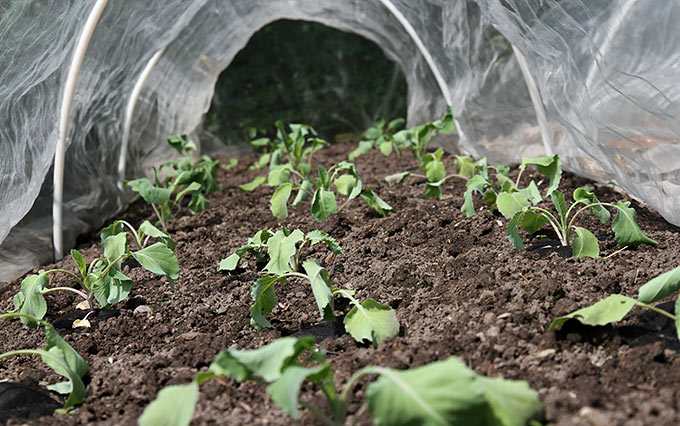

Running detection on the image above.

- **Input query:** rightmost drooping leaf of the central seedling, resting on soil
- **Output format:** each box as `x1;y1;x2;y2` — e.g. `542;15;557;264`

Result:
337;290;399;347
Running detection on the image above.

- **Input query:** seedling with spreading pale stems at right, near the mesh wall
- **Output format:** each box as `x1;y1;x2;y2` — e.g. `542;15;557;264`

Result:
496;186;657;258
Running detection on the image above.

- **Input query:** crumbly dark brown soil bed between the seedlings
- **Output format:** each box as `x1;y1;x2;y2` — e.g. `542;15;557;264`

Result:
0;141;680;425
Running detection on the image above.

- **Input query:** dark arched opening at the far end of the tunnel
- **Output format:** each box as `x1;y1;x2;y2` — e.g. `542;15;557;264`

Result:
203;20;407;144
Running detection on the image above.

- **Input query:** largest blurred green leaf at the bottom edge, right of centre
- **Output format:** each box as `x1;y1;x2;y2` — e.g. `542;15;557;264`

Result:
366;357;543;426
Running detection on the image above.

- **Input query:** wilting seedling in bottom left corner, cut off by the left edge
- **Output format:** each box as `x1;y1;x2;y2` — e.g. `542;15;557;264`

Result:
0;312;89;409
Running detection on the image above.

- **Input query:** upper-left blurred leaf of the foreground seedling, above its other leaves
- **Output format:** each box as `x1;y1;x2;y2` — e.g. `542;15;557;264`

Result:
209;337;314;383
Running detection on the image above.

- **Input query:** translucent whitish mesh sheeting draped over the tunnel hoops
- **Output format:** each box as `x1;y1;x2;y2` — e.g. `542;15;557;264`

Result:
0;0;680;281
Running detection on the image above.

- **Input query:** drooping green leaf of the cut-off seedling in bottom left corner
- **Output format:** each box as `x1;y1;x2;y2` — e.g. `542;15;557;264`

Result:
40;324;89;408
